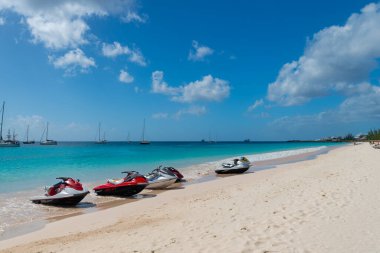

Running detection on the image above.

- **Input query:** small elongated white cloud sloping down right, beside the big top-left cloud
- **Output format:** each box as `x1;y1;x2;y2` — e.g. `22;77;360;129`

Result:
102;42;146;66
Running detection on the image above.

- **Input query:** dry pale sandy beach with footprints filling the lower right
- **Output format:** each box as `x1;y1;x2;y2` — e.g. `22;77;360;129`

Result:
0;143;380;253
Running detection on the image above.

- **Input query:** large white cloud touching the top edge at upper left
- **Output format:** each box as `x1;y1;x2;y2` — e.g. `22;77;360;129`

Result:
0;0;138;49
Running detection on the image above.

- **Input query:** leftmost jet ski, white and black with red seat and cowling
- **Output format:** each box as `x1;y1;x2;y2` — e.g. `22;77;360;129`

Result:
30;177;90;206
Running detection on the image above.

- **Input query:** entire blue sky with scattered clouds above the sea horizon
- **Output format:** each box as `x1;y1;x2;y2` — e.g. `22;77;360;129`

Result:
0;0;380;141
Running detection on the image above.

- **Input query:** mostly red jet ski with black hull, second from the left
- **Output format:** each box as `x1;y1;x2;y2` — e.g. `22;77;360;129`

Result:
94;171;148;196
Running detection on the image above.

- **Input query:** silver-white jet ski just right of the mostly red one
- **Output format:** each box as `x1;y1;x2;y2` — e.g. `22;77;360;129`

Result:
145;166;178;190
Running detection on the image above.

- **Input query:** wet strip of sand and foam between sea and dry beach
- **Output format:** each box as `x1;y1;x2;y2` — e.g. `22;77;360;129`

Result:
0;145;336;242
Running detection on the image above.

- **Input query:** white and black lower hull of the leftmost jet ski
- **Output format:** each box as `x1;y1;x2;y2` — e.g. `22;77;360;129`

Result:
31;191;90;206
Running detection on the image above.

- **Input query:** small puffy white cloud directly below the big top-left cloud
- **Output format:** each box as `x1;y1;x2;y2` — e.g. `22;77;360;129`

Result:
50;48;96;74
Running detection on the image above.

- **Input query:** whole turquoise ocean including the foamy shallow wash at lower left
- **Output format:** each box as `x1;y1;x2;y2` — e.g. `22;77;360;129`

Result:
0;142;342;237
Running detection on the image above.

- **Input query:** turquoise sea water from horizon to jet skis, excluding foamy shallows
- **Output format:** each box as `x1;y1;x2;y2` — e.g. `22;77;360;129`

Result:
0;142;339;193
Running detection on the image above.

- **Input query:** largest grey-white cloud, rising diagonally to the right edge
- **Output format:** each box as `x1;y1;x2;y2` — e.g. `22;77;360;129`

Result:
267;4;380;106
